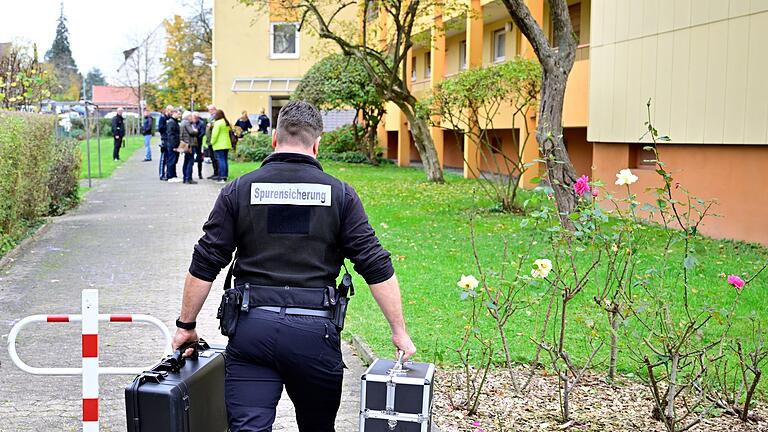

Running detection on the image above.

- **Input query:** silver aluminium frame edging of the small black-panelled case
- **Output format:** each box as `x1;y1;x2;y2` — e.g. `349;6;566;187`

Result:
359;358;435;432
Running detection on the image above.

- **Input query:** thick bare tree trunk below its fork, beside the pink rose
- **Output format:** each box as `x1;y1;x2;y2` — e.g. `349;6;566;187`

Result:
536;68;576;223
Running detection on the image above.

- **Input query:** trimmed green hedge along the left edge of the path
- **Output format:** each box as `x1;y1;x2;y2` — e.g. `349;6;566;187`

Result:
0;112;81;255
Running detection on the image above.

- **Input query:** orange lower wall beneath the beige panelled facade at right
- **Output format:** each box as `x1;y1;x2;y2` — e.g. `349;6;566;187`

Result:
593;143;768;245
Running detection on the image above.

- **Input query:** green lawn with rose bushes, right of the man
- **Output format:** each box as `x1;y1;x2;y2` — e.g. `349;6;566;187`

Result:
230;162;768;390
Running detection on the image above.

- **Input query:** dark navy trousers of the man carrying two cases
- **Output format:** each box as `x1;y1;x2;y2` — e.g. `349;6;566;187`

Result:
225;308;344;432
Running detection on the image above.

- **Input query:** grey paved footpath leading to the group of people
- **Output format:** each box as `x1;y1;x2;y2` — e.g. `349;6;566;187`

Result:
0;146;363;432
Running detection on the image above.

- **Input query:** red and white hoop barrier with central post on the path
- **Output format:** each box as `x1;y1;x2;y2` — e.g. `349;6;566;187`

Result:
8;289;172;432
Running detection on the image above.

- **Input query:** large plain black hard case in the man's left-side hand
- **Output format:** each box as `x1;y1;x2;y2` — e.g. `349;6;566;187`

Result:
125;346;228;432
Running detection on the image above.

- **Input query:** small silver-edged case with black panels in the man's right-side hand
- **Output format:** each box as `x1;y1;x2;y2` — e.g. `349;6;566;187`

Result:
360;359;435;432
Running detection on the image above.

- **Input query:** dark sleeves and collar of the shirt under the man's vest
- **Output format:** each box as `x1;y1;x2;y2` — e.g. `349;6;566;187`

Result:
189;153;395;284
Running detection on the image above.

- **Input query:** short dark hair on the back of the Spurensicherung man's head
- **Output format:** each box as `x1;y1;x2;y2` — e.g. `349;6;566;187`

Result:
277;100;323;147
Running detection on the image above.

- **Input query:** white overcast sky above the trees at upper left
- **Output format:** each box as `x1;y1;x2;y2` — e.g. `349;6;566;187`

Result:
0;0;200;81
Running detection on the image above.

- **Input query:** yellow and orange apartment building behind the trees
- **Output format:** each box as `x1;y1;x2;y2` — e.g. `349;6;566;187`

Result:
214;0;768;244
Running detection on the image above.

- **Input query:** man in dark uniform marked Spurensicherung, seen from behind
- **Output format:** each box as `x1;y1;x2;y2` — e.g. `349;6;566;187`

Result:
173;101;416;432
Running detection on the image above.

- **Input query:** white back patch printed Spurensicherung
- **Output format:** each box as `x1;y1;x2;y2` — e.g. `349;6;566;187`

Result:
251;183;331;207
